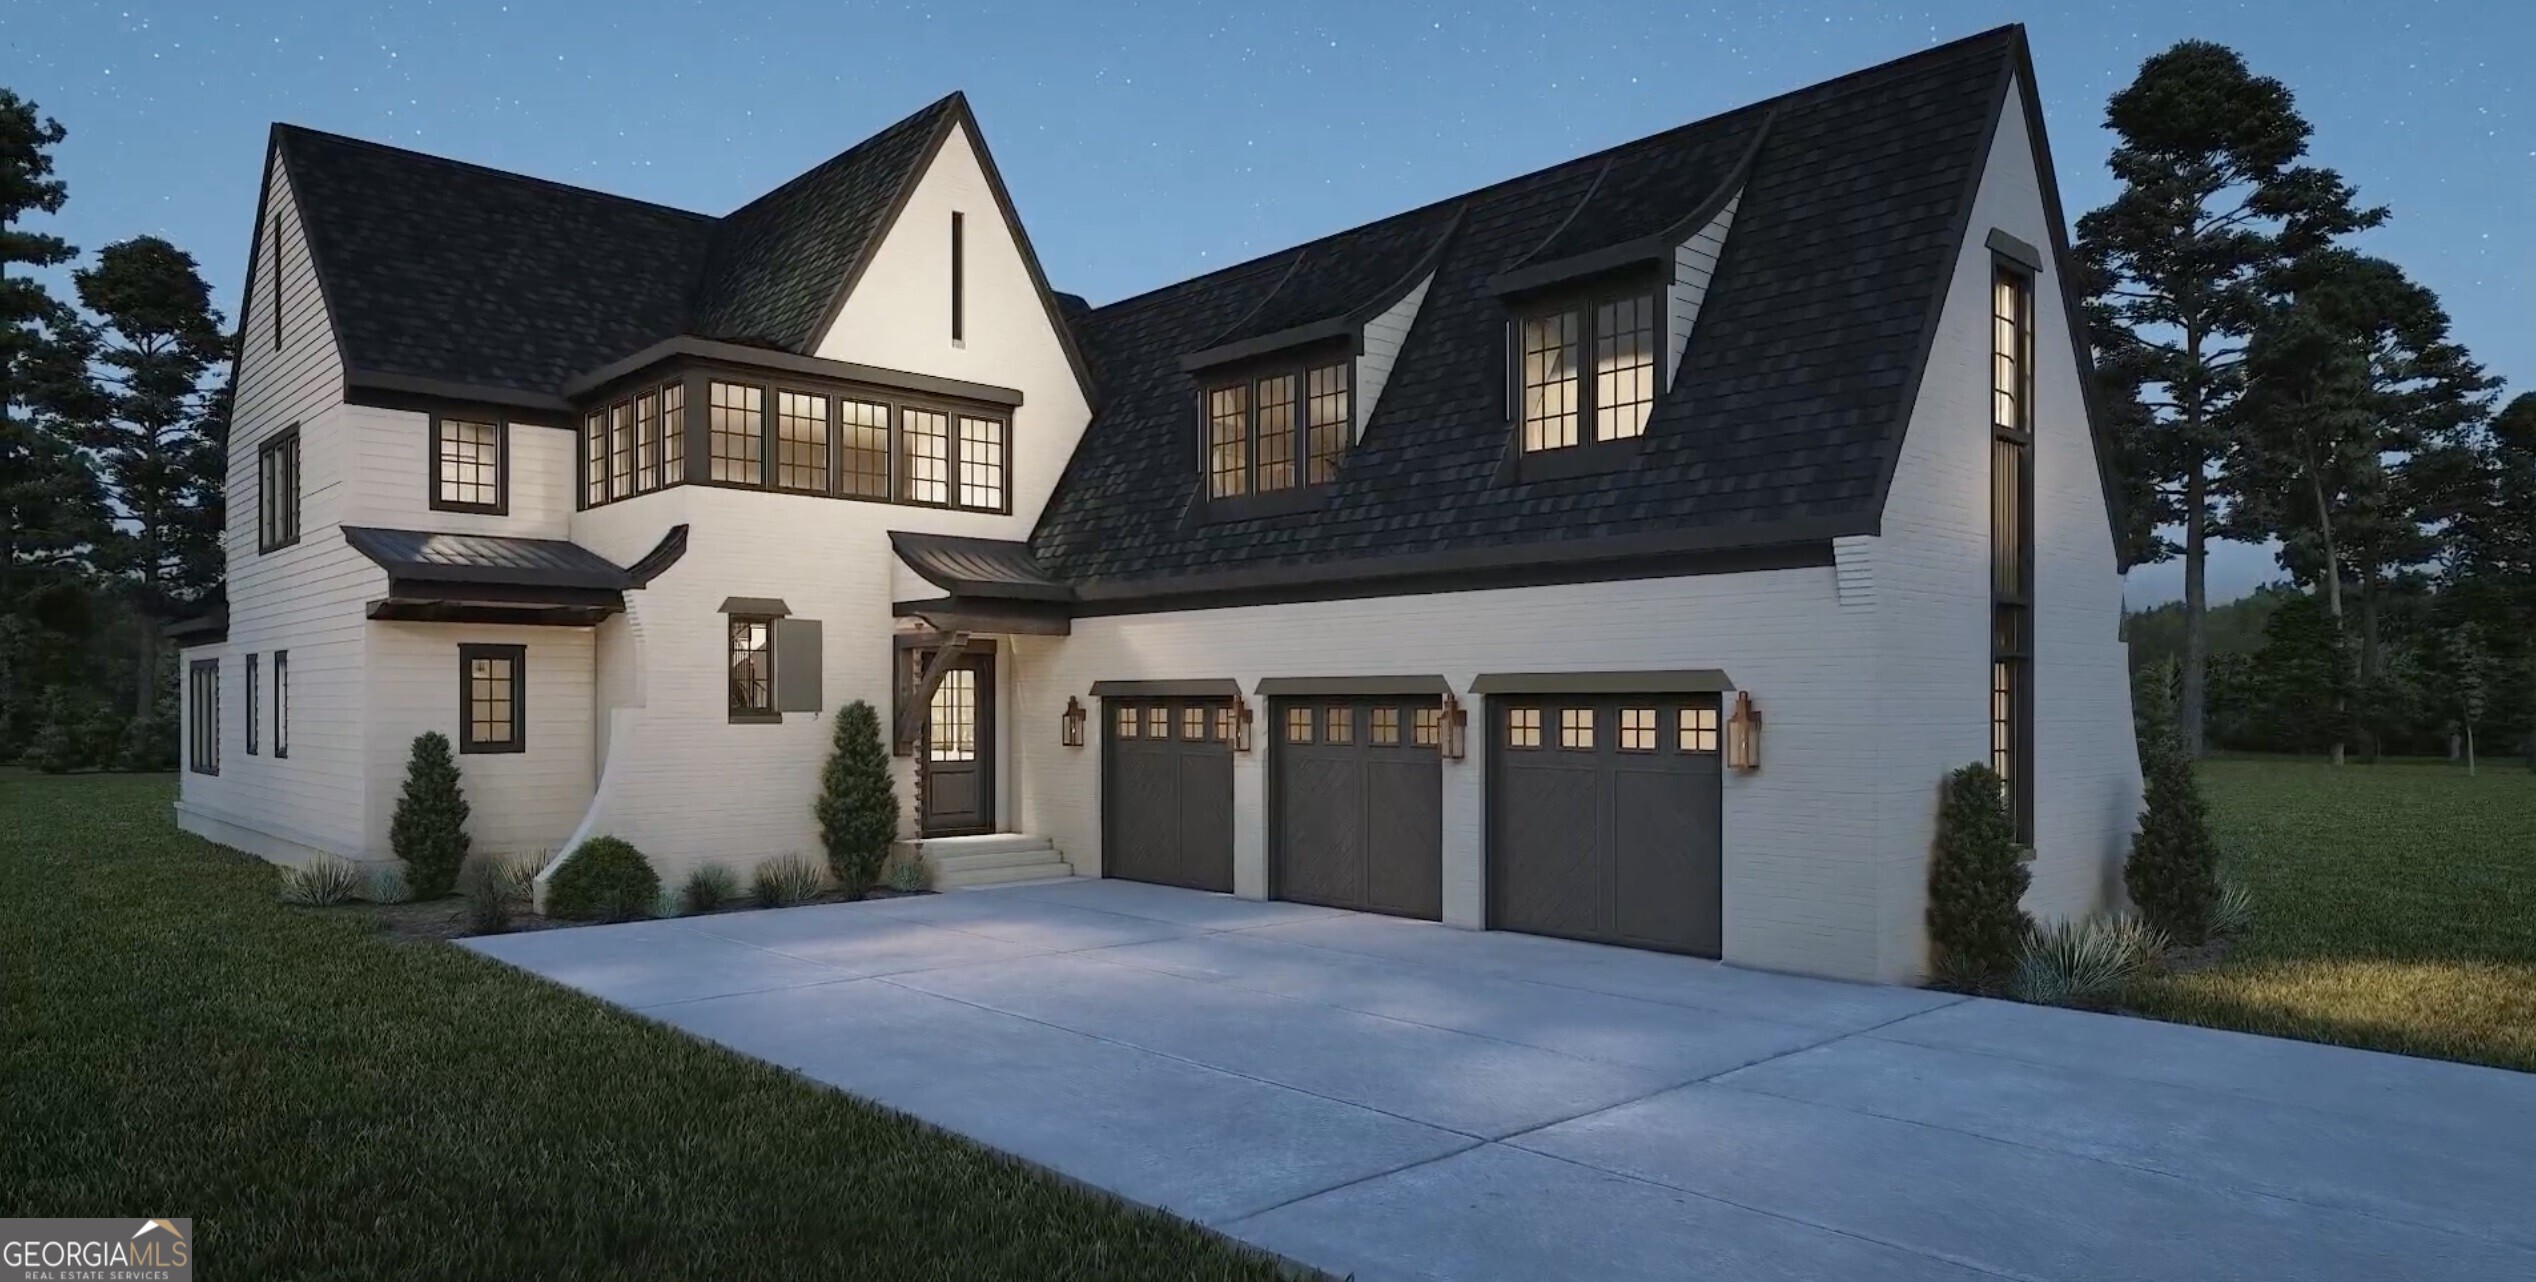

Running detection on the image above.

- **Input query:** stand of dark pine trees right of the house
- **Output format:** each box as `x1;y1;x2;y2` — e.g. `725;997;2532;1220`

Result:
2077;41;2536;763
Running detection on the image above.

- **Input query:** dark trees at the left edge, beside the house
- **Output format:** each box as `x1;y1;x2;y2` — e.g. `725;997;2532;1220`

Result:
0;89;236;770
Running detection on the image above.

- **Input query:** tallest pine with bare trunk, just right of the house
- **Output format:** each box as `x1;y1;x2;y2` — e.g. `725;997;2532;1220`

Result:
2077;41;2384;755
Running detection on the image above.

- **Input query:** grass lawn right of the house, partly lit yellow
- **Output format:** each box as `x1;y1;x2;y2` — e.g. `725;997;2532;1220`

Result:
2128;758;2536;1072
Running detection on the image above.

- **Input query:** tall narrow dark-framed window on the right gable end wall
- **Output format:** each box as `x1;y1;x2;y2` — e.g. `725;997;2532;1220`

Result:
1991;263;2034;844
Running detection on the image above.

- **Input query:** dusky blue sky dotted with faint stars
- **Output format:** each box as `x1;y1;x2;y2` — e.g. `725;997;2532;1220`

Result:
0;0;2536;606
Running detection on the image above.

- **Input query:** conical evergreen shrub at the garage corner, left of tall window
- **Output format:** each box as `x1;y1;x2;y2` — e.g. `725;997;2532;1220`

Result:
1927;763;2031;988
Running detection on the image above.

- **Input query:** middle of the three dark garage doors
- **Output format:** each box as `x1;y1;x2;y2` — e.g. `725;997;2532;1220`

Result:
1268;697;1443;920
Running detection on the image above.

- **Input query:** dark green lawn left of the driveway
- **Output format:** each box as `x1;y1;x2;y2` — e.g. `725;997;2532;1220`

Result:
0;773;1281;1279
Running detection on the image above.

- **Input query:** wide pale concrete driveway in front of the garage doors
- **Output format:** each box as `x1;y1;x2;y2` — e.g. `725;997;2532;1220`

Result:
467;882;2536;1279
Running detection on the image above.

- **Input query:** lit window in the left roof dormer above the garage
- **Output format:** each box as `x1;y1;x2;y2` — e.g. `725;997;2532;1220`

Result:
1205;360;1352;499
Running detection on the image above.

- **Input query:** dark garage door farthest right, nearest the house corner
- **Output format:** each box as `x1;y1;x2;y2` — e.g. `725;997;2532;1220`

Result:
1489;694;1722;958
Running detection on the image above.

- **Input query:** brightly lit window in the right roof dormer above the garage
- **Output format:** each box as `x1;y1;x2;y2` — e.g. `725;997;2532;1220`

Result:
1517;291;1656;454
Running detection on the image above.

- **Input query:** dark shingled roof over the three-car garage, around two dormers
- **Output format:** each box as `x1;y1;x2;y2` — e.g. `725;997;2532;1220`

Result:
1032;28;2099;598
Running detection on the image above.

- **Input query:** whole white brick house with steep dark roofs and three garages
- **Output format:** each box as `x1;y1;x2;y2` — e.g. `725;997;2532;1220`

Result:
178;28;2140;981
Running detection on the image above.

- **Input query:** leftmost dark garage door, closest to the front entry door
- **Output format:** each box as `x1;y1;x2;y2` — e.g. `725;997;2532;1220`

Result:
1101;699;1232;892
